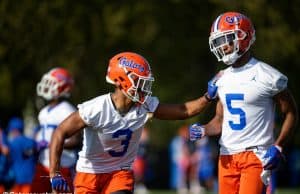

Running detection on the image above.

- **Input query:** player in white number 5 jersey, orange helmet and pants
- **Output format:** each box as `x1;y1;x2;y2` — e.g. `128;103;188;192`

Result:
190;12;298;194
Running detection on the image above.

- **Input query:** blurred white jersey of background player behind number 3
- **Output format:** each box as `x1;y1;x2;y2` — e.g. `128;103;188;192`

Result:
36;101;77;167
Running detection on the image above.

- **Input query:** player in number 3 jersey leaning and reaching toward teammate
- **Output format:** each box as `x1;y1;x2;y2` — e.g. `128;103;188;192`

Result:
50;52;217;194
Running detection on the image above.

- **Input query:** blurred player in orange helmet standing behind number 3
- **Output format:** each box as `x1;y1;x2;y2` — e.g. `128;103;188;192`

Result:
32;67;81;193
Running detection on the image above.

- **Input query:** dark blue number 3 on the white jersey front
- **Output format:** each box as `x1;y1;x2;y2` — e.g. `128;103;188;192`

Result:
108;129;132;157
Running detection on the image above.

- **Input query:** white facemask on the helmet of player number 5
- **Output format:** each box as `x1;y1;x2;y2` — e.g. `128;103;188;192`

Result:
209;29;247;65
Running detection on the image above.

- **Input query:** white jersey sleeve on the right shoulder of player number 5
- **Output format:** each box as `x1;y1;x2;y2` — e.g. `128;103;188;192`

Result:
260;62;288;96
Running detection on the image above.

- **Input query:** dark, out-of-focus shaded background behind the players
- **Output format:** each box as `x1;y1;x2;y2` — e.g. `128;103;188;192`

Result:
0;0;300;190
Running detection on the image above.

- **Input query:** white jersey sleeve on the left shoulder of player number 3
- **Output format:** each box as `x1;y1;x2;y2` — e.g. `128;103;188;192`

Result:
77;99;100;126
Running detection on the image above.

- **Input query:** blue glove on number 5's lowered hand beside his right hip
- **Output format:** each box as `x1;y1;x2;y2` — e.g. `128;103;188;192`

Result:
263;145;284;170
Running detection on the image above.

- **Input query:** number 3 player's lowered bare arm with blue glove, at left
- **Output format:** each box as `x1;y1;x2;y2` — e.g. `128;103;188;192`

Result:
49;111;86;192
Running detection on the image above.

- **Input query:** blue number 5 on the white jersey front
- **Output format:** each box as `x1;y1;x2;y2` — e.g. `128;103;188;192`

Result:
226;94;246;130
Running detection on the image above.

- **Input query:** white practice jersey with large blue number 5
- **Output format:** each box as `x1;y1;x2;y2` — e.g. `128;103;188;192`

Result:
216;58;288;155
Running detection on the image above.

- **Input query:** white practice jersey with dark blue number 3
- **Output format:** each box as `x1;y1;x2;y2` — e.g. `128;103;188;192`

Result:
76;94;159;173
